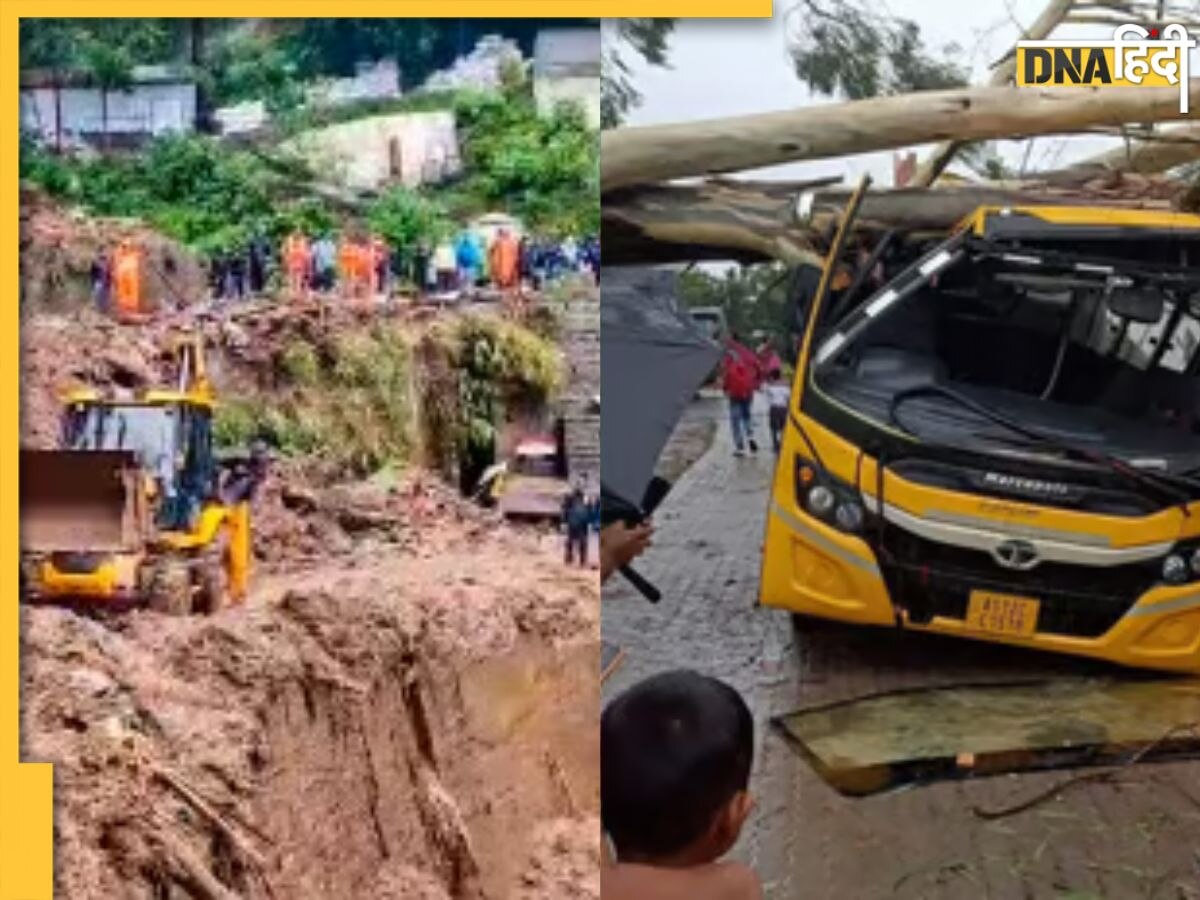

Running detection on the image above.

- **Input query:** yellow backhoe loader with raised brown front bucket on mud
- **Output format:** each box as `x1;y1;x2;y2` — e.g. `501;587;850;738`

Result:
20;336;266;614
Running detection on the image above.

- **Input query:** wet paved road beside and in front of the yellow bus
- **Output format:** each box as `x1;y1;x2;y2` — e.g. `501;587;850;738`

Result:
604;403;1200;900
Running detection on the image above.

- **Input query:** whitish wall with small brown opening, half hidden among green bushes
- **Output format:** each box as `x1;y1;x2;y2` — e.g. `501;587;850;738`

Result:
283;110;462;190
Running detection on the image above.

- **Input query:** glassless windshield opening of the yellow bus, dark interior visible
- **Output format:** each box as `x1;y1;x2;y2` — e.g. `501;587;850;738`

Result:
812;226;1200;476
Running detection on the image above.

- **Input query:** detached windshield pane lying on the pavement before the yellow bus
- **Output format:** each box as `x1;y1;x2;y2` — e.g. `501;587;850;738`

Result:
775;678;1200;796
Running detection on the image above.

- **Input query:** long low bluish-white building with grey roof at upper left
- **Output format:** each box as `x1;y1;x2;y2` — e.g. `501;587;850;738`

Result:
20;66;196;146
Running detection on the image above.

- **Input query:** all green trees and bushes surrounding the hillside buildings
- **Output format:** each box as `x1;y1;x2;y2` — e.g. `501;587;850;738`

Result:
20;19;600;253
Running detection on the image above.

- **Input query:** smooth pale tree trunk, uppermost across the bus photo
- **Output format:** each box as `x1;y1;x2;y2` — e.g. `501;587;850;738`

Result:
600;79;1200;192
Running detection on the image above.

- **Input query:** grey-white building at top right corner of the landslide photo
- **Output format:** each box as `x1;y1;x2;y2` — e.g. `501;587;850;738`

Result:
533;28;600;128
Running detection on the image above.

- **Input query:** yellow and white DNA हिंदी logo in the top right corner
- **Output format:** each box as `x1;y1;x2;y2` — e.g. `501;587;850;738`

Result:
1016;24;1196;115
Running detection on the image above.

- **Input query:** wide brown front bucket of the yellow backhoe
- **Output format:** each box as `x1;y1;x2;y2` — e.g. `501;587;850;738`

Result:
20;450;149;553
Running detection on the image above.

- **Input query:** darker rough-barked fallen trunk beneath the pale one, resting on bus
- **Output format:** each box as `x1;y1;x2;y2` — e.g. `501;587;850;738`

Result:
601;178;1183;265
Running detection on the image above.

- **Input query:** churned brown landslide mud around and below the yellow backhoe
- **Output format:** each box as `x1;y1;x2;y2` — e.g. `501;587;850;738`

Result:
23;300;599;900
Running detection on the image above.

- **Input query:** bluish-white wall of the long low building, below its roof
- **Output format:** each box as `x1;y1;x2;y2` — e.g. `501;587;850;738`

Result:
20;84;196;143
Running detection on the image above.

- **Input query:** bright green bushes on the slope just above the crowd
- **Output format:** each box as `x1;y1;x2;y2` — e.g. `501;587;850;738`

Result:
20;86;600;253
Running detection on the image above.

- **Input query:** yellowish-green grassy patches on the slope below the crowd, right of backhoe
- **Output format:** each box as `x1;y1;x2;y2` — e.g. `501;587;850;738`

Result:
216;316;564;475
